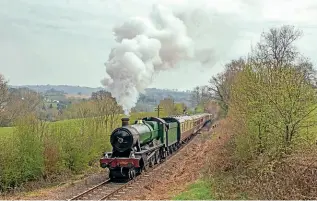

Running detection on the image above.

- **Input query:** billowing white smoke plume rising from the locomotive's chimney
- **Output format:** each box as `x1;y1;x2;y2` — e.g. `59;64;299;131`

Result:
102;5;235;115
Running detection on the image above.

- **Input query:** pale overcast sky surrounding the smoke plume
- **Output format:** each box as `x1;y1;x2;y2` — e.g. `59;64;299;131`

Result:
0;0;317;90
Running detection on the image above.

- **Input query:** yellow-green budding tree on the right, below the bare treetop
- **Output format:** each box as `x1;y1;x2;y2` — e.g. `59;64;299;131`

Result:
229;66;317;154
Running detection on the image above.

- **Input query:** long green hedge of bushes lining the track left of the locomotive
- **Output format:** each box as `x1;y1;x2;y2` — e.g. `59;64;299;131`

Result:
0;110;164;191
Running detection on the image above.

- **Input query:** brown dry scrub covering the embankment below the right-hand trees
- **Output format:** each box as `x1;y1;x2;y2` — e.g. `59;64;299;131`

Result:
204;119;317;199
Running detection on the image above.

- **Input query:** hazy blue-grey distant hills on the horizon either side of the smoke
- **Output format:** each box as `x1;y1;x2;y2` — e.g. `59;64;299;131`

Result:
10;85;190;105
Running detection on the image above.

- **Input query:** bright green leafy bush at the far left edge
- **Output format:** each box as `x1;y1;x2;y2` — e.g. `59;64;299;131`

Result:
0;116;44;190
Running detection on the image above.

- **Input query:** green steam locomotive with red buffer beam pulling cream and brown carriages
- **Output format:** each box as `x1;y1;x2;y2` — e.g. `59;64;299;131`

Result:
100;113;213;180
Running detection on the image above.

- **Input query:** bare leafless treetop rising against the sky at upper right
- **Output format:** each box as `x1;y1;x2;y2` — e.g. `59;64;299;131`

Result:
250;25;317;85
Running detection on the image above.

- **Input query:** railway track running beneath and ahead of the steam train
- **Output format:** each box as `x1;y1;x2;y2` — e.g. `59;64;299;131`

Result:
69;121;217;200
